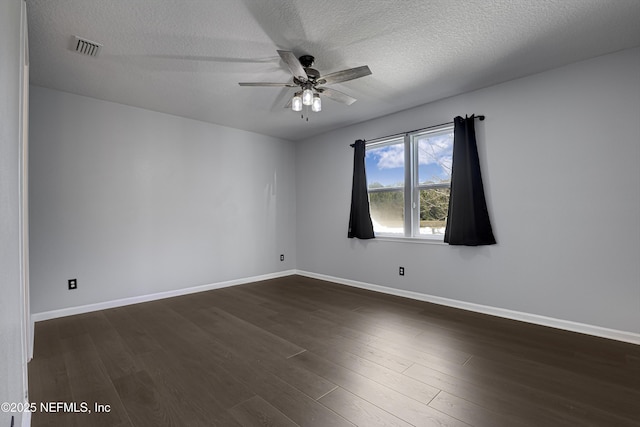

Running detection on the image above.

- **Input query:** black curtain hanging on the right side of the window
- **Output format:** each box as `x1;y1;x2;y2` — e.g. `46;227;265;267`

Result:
444;115;496;246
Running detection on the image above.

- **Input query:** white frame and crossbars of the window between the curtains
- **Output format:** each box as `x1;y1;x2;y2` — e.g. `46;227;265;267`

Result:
366;124;453;242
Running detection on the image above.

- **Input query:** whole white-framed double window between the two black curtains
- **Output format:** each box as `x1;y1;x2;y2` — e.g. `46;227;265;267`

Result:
365;125;453;240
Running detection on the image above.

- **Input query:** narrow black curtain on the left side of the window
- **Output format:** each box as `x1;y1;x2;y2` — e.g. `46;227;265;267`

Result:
347;139;375;239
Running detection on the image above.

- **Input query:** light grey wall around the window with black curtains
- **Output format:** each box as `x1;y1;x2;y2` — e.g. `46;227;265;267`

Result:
296;49;640;333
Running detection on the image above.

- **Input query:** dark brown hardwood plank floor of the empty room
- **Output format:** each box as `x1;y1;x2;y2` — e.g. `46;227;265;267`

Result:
29;276;640;427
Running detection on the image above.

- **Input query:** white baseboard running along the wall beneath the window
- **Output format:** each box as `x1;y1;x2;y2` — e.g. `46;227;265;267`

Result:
296;270;640;344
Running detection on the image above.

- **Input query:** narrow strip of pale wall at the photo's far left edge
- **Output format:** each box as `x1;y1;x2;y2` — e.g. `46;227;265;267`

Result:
0;0;26;426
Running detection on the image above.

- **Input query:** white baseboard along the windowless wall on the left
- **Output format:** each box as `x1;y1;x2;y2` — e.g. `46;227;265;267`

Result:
31;270;296;324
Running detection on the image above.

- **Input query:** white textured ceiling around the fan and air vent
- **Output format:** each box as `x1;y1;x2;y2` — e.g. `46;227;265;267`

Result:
27;0;640;140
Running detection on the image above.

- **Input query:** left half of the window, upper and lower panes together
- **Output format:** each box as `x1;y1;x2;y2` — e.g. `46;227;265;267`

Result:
365;139;405;236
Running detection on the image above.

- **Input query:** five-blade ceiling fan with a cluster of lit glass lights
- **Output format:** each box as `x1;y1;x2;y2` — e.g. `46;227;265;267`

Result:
238;50;371;112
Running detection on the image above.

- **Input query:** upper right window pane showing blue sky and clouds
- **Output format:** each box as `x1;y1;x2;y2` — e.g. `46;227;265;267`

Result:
416;129;453;184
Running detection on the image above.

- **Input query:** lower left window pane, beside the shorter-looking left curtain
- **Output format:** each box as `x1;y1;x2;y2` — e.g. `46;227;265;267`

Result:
369;189;404;235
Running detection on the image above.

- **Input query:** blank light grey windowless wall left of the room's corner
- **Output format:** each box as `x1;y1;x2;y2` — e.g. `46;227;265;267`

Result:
29;87;296;313
